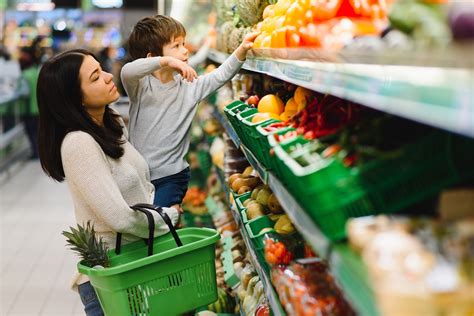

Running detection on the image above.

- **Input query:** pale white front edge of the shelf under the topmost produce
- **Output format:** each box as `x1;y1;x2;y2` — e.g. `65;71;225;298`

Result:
209;50;474;138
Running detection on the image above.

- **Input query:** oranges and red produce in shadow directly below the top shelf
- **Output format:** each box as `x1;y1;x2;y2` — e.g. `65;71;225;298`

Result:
237;73;433;167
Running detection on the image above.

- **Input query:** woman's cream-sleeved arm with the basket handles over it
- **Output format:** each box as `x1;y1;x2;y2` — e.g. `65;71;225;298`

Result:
61;132;179;238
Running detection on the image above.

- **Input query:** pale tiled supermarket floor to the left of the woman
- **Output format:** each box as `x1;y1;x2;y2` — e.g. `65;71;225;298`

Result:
0;162;84;316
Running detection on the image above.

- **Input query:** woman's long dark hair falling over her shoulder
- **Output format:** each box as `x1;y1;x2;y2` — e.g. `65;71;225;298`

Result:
37;49;124;182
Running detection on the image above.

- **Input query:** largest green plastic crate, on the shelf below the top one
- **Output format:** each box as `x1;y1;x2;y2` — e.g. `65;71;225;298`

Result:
275;131;474;240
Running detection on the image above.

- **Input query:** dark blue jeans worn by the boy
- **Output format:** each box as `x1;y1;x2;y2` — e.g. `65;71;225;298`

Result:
151;167;191;207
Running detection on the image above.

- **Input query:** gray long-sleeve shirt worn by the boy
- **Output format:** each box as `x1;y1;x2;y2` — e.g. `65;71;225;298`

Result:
121;54;243;180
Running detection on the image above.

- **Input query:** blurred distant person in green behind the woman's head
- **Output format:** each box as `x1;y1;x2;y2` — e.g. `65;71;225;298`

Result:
19;42;40;159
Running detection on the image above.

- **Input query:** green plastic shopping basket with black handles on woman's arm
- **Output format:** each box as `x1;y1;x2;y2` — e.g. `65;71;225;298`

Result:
78;204;220;316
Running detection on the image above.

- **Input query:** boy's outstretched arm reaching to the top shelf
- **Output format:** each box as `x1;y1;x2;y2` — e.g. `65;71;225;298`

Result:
190;32;259;103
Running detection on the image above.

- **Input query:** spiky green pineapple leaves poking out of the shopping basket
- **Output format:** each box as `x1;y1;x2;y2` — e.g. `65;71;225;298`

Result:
62;221;110;268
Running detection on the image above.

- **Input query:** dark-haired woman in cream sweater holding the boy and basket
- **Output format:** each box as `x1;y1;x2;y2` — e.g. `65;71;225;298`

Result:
37;50;179;316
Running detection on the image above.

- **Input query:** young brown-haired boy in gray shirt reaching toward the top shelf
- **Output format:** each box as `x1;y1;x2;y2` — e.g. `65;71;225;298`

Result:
121;15;258;207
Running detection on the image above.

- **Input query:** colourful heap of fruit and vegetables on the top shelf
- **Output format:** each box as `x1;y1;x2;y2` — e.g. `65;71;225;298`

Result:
215;0;474;58
